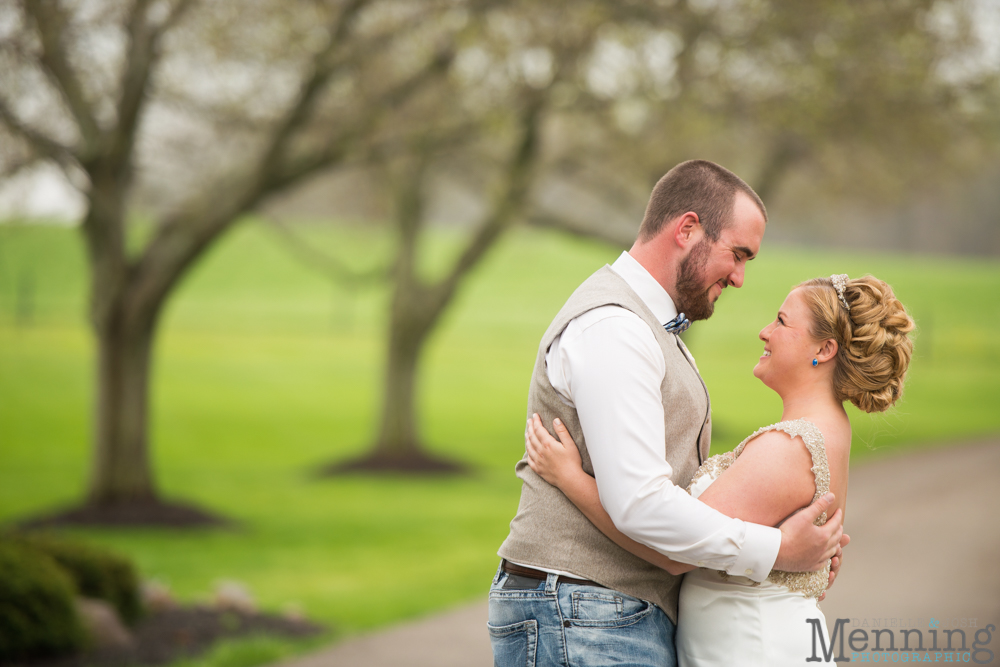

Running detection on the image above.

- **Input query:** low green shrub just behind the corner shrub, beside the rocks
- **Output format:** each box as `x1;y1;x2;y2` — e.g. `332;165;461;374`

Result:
5;533;142;625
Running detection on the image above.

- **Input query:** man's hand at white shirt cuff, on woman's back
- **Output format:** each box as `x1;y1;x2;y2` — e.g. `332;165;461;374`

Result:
774;493;844;572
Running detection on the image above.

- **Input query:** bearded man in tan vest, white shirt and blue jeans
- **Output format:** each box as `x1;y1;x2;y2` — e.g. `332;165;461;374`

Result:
489;160;841;667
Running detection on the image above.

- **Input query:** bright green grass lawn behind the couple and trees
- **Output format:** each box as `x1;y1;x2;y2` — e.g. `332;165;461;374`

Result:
0;222;1000;632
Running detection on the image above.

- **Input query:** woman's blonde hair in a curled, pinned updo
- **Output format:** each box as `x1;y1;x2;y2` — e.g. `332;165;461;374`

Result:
799;276;913;412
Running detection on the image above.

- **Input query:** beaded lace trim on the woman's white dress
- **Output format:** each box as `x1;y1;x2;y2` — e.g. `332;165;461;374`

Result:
687;419;830;597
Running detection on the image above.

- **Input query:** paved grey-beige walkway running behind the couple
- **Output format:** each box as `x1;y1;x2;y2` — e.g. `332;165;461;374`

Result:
282;440;1000;667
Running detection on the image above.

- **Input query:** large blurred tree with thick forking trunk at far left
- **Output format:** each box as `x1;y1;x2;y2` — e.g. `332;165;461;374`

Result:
0;0;458;523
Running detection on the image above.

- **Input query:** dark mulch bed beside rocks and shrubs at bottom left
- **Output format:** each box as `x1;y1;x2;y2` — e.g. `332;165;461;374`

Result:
25;607;325;667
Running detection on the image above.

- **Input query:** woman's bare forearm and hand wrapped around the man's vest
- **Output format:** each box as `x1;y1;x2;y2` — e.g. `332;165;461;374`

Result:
524;415;695;574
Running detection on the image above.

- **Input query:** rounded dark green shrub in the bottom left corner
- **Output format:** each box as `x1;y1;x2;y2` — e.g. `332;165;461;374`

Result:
0;542;84;662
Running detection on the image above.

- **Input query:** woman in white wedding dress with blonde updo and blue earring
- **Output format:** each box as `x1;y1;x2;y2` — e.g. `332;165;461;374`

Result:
525;274;913;667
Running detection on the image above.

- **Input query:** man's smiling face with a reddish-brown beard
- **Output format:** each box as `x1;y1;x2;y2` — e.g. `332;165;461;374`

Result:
676;192;765;320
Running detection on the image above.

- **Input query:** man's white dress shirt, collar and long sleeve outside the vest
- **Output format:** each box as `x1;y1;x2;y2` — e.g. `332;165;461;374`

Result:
545;252;781;581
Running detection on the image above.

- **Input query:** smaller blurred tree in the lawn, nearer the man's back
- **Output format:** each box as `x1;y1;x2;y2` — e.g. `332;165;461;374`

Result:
274;2;606;473
